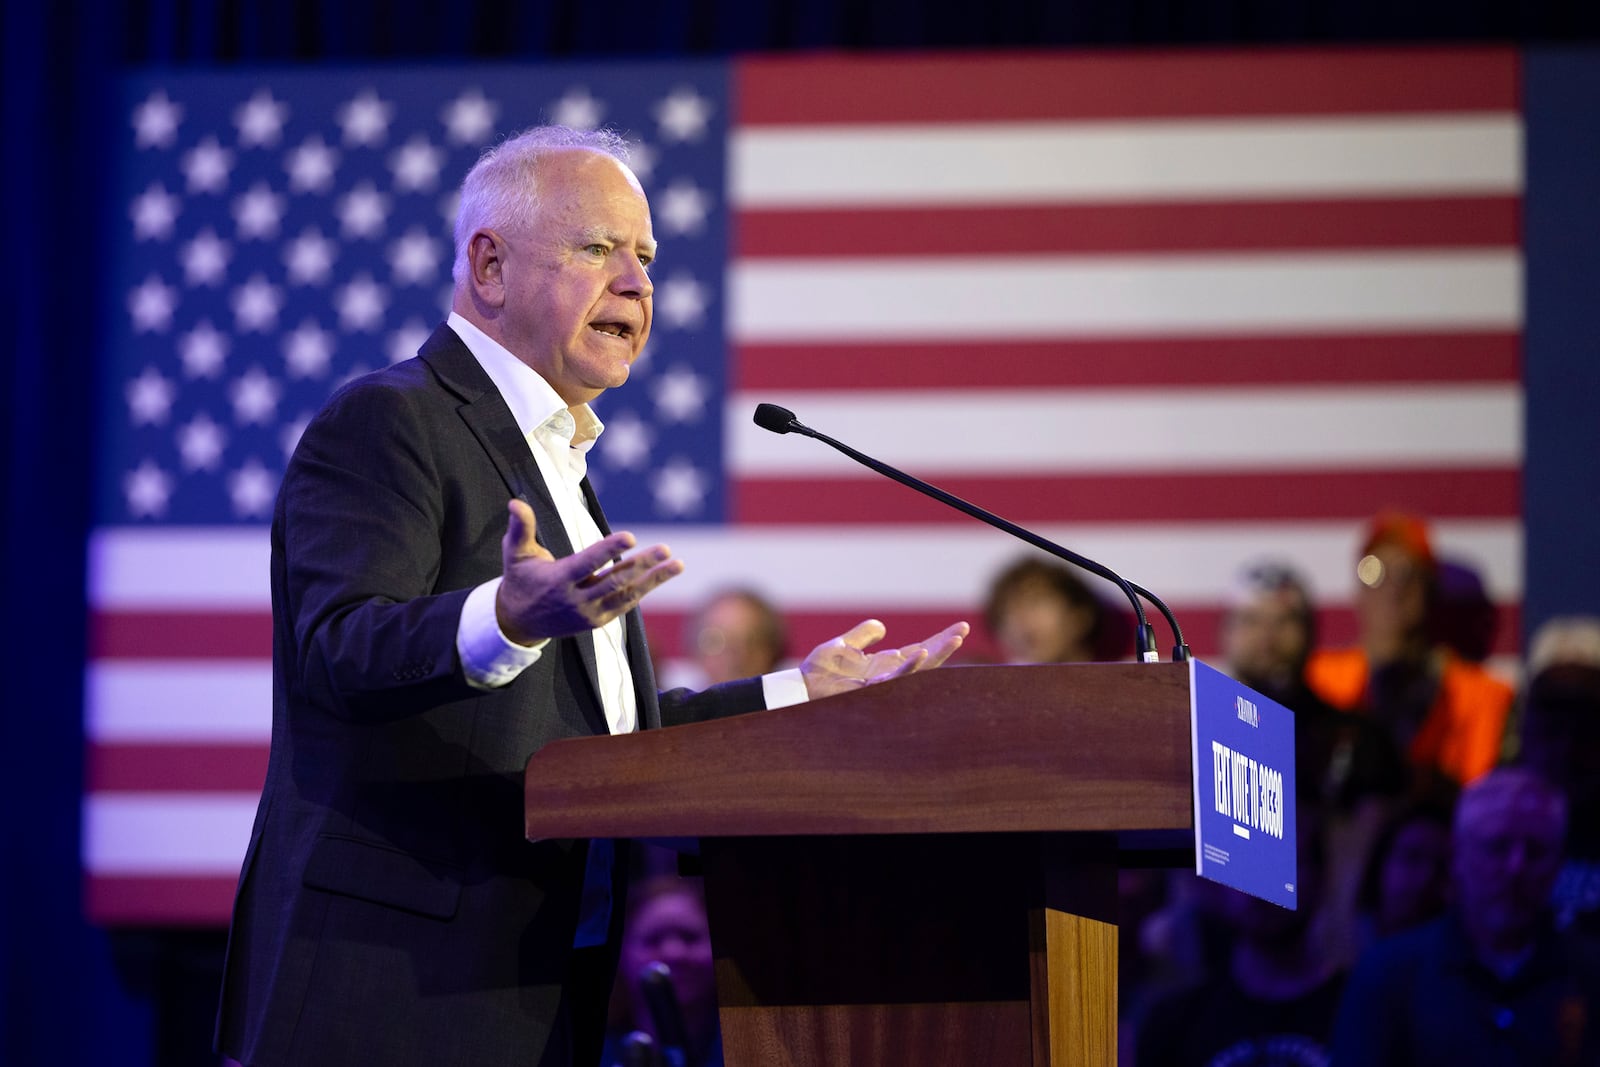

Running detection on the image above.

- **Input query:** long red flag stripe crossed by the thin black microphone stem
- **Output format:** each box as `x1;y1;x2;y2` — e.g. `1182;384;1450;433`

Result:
730;467;1522;526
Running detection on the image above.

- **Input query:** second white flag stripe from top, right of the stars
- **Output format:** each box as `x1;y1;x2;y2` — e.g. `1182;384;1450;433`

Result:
728;250;1522;342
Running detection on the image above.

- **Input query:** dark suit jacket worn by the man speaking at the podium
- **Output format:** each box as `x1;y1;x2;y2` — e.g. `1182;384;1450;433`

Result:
218;326;762;1067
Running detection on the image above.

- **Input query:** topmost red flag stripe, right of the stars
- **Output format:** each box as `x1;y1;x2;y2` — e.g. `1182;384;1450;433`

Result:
733;48;1520;126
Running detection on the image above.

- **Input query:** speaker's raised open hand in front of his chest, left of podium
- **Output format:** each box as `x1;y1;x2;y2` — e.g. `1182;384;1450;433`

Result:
494;499;683;645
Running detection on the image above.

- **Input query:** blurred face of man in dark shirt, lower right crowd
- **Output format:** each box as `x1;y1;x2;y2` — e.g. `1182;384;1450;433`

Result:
1454;769;1566;952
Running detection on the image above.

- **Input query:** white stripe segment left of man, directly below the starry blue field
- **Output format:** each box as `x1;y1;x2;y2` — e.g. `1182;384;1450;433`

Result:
88;526;272;608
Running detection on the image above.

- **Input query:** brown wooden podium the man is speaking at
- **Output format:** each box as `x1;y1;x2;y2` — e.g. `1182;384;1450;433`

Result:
525;664;1194;1067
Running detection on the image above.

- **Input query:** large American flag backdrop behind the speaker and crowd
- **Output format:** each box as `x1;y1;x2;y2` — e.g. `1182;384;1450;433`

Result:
83;50;1523;923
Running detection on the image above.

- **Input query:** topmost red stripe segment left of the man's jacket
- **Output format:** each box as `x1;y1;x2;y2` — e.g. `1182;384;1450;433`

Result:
88;609;272;659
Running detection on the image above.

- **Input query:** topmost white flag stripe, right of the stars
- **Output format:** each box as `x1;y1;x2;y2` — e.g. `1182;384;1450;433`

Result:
728;112;1522;208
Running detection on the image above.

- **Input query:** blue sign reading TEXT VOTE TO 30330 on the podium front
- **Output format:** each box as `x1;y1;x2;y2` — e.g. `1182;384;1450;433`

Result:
1189;659;1298;910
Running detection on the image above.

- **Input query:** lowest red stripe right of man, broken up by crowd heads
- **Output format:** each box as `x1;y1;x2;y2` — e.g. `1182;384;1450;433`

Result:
645;604;1522;664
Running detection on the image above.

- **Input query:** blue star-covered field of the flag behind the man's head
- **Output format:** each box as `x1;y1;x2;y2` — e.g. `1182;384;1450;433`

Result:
108;62;728;526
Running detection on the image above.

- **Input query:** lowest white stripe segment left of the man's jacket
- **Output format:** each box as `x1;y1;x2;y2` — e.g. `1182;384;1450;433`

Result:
83;792;258;877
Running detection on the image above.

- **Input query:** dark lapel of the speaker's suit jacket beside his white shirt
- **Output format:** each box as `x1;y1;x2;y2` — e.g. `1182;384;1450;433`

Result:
418;325;610;734
